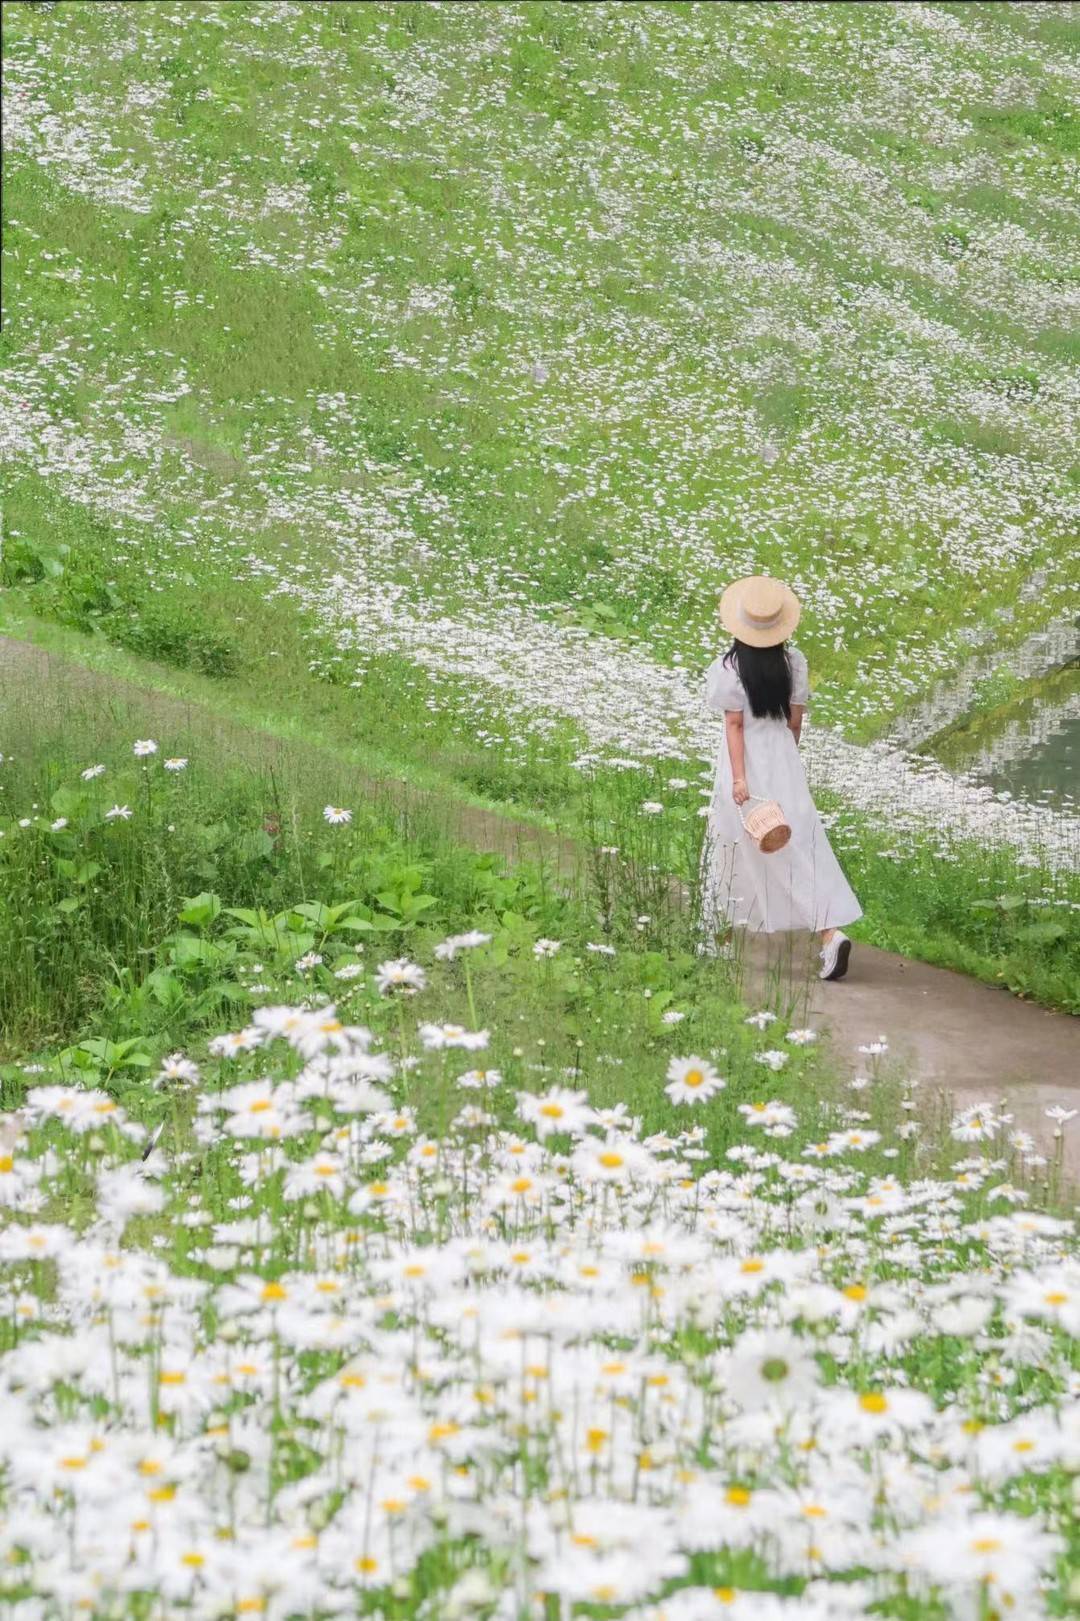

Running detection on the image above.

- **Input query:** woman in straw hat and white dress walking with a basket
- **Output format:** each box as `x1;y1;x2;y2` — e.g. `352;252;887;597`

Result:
702;574;863;979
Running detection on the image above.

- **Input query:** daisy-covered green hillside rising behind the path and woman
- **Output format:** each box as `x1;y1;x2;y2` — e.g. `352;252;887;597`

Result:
3;5;1075;1005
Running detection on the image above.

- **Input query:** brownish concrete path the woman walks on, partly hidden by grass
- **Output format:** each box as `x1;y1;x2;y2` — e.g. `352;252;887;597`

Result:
0;637;1080;1175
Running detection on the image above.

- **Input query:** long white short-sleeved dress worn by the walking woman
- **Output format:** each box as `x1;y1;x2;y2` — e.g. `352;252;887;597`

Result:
702;647;863;942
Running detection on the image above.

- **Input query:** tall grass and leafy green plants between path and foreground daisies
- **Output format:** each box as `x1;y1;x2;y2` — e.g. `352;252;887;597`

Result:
0;664;869;1173
